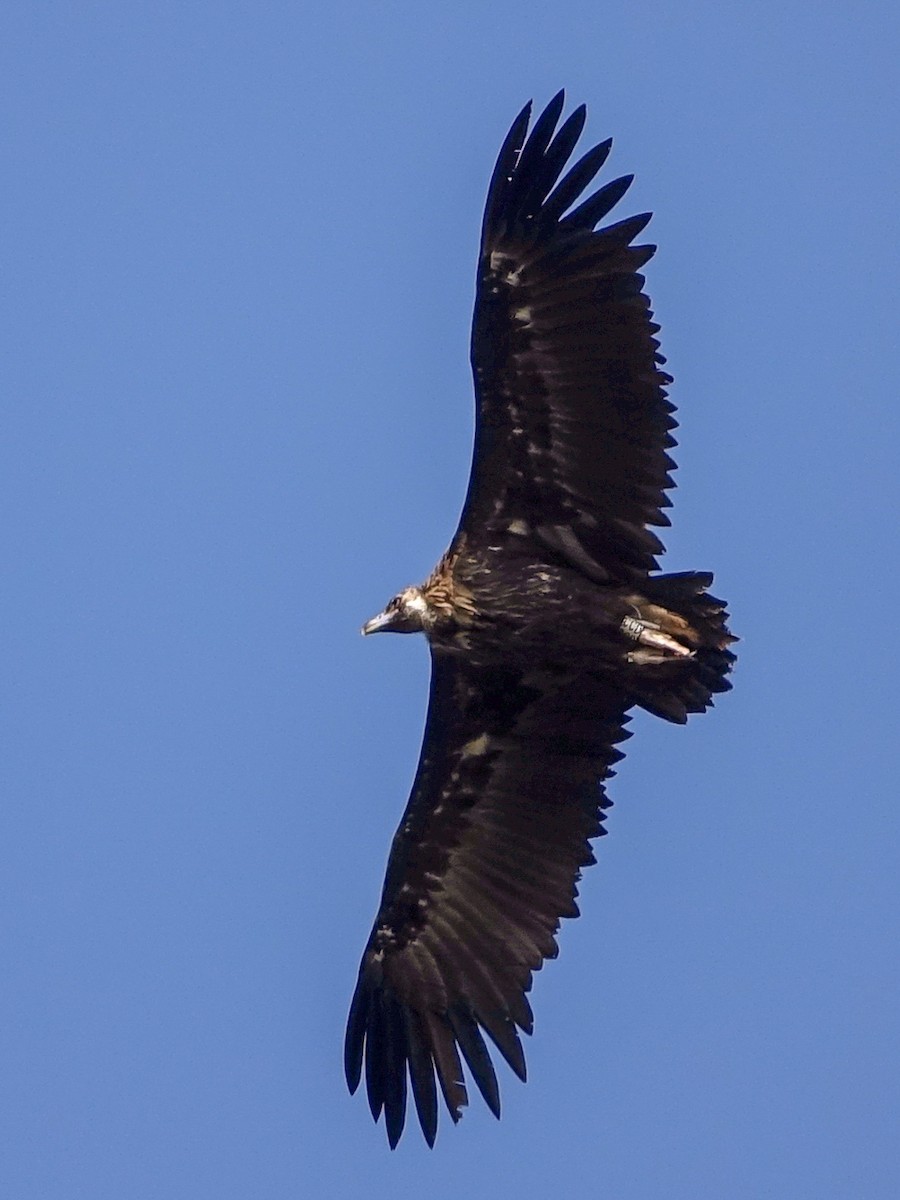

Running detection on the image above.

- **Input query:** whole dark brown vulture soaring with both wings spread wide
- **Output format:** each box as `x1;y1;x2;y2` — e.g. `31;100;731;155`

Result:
344;92;736;1147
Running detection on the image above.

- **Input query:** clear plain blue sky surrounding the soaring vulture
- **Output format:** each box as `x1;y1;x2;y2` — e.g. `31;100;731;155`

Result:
0;0;900;1200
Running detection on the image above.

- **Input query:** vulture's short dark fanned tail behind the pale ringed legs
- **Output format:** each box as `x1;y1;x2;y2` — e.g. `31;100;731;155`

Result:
635;571;737;725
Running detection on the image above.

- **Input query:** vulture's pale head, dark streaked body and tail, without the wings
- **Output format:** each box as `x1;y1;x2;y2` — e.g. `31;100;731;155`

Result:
364;549;734;721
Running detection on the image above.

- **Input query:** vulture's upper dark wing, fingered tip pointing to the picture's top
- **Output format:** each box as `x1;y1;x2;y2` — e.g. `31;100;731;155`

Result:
460;94;676;582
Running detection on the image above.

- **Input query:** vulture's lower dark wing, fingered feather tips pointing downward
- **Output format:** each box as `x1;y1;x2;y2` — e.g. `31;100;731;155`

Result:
346;652;629;1146
